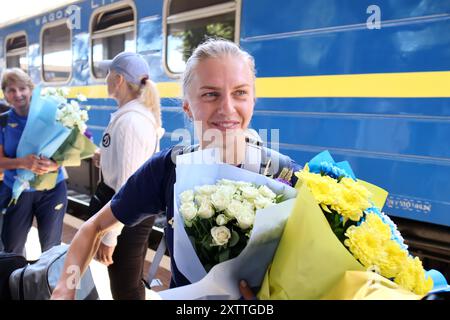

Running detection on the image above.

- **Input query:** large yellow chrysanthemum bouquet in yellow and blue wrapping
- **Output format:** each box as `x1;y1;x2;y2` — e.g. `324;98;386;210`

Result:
258;151;442;299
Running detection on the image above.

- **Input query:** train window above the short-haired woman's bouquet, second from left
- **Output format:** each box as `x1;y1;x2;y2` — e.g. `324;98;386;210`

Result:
42;23;72;82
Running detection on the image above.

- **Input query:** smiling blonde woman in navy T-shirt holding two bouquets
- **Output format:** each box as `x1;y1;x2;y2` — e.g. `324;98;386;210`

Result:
52;39;300;299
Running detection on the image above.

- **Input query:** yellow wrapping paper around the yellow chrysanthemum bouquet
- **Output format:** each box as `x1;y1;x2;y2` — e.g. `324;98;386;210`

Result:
258;180;414;300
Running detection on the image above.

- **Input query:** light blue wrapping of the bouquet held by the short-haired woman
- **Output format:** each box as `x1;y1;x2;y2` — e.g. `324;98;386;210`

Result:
11;86;71;202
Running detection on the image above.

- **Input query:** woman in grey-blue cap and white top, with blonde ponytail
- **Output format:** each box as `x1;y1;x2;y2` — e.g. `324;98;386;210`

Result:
90;52;164;300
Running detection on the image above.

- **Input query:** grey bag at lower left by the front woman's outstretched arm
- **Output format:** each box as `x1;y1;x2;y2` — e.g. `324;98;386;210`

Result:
9;245;99;300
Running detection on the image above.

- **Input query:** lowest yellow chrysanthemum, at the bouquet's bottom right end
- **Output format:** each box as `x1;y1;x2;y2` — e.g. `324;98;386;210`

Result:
394;257;433;295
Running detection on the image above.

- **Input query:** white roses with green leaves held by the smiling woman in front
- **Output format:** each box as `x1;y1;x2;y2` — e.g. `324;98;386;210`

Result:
179;179;283;272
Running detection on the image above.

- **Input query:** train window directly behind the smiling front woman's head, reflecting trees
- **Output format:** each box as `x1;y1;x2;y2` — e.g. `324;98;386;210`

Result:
164;0;240;74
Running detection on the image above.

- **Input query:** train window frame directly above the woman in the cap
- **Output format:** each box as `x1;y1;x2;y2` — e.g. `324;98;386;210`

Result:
89;0;138;83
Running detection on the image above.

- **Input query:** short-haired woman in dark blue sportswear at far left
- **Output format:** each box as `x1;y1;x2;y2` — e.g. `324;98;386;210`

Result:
0;68;67;254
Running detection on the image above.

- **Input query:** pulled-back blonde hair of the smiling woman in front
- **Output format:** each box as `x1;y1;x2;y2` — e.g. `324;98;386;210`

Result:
182;38;256;99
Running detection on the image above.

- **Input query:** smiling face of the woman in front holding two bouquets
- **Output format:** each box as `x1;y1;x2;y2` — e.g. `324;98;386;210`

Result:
183;56;255;151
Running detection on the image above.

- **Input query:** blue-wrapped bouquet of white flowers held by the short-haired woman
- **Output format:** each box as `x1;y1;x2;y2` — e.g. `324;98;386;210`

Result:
10;86;96;205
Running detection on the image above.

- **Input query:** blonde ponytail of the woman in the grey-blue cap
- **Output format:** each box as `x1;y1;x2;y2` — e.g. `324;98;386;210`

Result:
127;78;162;128
